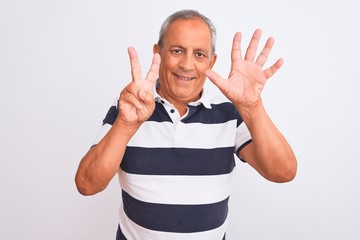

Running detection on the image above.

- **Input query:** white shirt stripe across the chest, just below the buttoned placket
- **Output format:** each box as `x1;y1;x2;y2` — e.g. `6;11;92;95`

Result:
128;120;236;149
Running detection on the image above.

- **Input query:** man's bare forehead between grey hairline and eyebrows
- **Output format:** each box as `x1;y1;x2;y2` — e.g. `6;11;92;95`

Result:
164;18;212;51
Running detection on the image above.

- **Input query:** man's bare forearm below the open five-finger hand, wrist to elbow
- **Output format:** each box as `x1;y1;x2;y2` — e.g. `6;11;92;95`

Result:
237;100;297;182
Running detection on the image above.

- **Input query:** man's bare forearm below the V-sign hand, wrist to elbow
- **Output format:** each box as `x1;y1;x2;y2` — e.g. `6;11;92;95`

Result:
75;121;137;195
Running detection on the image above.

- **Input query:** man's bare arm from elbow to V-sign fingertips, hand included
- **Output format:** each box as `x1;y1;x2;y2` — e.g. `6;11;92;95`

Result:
75;48;160;195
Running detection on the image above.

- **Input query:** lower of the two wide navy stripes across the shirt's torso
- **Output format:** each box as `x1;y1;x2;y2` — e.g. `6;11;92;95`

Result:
122;191;229;233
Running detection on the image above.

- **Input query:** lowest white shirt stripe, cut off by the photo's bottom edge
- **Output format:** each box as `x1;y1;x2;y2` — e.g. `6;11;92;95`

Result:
119;203;227;240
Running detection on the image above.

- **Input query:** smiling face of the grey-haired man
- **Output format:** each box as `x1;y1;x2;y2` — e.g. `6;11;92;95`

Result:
154;19;216;105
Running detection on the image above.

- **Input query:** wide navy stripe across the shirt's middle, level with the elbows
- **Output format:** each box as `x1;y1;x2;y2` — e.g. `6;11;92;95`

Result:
120;147;235;175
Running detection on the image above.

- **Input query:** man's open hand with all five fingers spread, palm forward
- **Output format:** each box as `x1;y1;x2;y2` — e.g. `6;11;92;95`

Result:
206;29;283;107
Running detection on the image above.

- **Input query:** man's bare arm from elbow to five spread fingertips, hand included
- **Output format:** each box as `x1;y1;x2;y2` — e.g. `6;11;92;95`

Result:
207;30;297;182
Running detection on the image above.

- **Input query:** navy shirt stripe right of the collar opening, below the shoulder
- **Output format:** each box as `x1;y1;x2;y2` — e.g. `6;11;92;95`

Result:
182;102;242;125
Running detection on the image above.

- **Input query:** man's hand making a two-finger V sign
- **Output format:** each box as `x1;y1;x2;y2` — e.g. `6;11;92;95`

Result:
118;48;160;126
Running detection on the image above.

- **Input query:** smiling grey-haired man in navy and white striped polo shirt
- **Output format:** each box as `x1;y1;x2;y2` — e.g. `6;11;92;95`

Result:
76;10;297;240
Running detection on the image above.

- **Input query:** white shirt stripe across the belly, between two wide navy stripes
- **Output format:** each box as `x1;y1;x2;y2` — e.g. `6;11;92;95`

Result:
118;170;232;204
